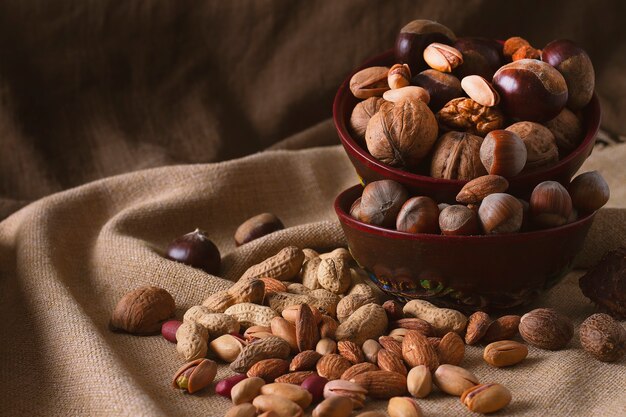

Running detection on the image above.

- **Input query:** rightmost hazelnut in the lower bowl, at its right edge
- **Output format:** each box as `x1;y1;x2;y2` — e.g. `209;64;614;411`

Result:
567;171;611;213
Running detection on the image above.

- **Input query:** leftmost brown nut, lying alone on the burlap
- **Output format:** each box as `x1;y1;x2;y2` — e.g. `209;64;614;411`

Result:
109;286;176;334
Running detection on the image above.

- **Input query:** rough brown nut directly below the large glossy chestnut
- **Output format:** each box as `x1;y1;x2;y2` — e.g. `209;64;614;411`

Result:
506;122;559;172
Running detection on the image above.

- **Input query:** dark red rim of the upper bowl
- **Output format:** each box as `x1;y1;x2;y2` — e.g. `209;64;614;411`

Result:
333;49;602;187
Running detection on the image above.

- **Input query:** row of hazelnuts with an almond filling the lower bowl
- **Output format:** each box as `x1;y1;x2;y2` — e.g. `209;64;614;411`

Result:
350;168;609;235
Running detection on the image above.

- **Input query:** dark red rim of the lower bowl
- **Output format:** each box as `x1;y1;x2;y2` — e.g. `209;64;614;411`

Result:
333;184;597;243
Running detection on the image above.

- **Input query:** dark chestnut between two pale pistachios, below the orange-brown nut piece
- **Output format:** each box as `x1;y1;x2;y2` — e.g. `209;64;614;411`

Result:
453;38;503;80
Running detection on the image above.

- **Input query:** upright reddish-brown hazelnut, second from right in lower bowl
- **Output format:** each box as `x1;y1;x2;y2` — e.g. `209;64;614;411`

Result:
529;181;572;228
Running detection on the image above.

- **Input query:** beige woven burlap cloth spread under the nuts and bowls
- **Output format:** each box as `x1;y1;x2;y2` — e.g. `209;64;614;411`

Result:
0;146;626;417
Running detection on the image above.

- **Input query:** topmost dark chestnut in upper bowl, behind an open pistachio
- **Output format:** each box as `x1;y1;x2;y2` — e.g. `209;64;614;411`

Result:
394;19;456;74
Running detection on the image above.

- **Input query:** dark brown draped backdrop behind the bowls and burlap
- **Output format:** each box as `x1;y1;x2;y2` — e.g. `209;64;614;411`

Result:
0;0;626;219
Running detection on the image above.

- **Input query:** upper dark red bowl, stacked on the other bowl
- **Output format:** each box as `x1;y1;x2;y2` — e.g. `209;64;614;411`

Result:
333;50;601;203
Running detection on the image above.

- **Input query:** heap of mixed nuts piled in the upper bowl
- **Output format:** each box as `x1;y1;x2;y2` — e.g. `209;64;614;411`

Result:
349;20;595;180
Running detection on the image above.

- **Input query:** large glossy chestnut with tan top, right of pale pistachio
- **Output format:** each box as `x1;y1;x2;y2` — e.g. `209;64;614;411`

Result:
493;59;567;122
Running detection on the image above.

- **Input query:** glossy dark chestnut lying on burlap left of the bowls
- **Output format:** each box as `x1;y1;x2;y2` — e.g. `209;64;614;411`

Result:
166;229;221;275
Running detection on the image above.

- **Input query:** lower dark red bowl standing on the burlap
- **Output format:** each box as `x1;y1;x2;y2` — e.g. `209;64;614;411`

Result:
335;185;594;310
